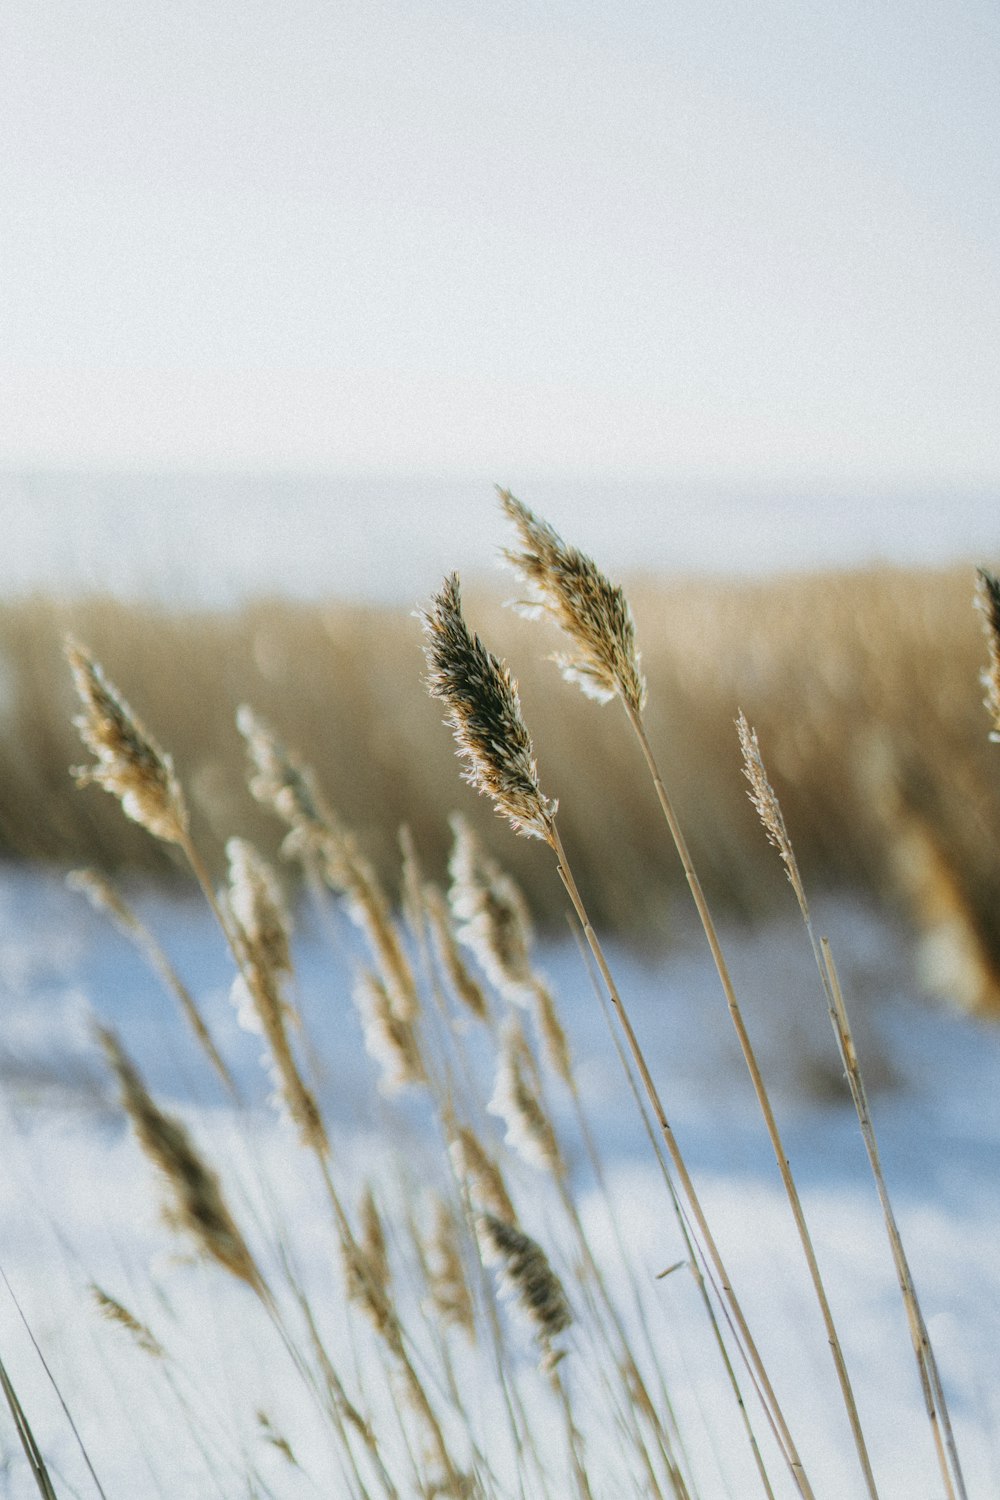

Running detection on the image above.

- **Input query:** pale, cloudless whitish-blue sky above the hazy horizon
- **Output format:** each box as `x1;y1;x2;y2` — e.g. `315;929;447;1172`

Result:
0;0;1000;489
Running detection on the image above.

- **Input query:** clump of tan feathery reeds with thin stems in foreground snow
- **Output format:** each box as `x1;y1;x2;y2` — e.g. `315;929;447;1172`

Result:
27;534;983;1500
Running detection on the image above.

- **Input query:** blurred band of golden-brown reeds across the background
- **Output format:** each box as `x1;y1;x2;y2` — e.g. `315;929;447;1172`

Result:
0;569;1000;1011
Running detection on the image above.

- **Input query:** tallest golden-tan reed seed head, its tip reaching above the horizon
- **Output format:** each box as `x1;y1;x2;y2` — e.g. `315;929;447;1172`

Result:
498;489;646;714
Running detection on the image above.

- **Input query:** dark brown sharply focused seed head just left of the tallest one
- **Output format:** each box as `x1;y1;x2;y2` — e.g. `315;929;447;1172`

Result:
421;573;556;843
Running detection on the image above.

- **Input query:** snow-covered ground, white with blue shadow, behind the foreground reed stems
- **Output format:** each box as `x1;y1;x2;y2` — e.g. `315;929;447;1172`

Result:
0;869;1000;1500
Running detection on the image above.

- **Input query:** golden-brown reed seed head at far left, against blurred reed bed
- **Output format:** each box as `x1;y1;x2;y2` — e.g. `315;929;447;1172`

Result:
66;639;187;843
